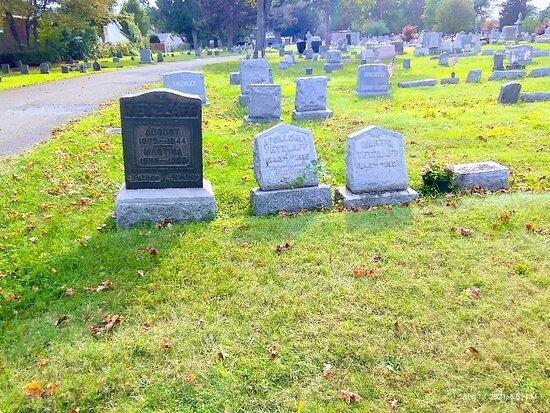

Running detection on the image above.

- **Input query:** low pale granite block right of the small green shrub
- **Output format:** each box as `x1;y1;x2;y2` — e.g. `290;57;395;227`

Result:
450;161;510;191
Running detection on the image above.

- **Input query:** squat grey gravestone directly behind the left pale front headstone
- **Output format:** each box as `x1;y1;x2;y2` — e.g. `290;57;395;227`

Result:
244;83;282;123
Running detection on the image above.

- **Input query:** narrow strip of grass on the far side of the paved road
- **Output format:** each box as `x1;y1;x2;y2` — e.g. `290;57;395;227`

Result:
0;51;233;91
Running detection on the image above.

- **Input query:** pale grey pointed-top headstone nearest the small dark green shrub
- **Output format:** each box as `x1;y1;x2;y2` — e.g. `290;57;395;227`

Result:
336;126;418;208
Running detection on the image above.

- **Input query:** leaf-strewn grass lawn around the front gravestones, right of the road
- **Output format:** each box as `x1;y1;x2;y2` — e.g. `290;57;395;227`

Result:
0;43;550;413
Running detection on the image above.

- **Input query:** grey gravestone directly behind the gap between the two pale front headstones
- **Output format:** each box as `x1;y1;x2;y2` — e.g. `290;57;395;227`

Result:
292;76;332;120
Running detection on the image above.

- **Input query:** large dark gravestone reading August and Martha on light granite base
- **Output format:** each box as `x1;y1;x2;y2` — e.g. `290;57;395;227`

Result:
116;89;216;228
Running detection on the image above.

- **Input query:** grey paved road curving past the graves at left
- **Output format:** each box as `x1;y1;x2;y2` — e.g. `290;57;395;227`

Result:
0;56;238;156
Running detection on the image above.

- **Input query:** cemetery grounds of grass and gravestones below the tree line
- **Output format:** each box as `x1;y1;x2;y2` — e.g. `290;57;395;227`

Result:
0;1;550;413
